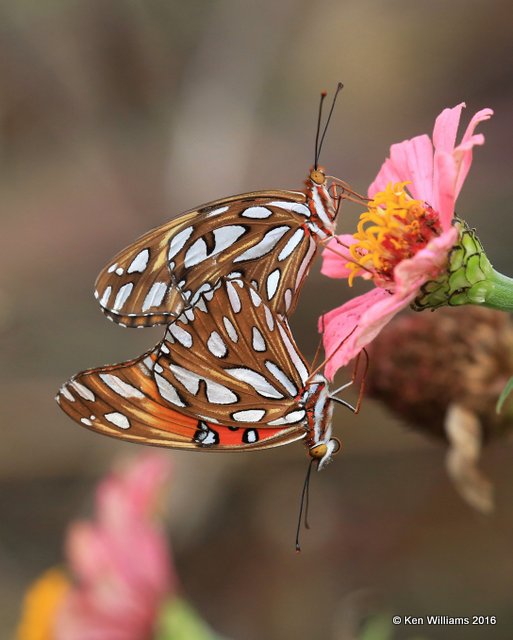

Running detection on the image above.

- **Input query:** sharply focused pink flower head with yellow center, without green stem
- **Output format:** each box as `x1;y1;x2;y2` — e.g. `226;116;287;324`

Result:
319;103;493;378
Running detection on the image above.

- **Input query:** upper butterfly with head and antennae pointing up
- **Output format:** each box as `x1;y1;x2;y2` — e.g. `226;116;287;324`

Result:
95;84;343;327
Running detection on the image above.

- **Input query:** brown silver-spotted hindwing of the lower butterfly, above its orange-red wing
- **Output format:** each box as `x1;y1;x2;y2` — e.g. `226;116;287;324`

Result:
154;279;309;427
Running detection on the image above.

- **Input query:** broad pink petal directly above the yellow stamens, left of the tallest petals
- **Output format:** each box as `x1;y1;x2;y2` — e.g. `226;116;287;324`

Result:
368;135;433;203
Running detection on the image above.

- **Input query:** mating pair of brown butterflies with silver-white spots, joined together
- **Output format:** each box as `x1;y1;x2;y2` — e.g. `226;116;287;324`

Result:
57;85;352;468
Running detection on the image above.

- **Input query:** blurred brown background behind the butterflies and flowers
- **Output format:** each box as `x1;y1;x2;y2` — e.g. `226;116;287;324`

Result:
0;0;513;640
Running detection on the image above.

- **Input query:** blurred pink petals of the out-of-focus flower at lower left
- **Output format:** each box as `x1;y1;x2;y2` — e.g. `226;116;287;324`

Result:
55;452;176;640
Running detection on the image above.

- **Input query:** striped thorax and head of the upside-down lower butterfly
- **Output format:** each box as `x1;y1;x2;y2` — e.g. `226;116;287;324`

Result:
302;375;340;469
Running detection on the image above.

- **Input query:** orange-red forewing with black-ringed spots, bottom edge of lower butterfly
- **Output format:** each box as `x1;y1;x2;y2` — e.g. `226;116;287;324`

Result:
56;347;305;451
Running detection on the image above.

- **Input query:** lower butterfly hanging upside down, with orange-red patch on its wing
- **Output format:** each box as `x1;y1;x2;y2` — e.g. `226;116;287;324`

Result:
56;278;350;469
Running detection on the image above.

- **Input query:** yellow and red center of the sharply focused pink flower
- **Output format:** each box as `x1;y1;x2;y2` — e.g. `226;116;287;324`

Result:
346;182;442;286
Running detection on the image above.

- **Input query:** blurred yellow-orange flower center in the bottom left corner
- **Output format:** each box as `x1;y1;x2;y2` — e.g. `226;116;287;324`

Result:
16;569;70;640
